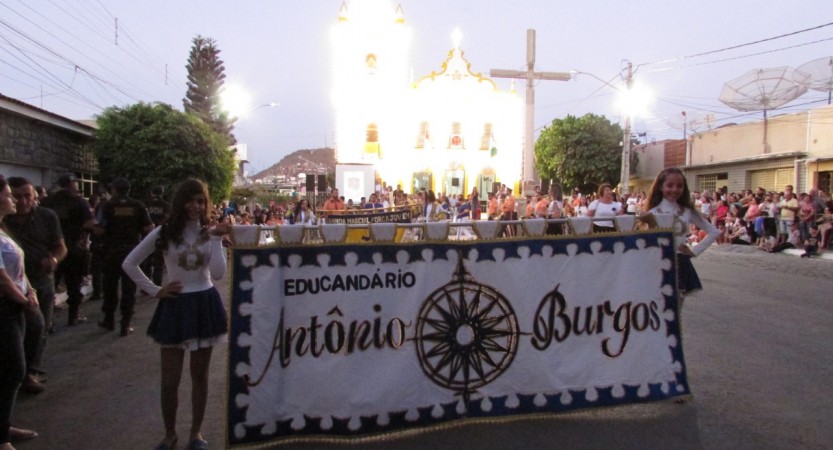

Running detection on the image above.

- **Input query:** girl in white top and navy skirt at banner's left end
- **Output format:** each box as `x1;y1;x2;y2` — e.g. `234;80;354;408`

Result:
122;179;231;449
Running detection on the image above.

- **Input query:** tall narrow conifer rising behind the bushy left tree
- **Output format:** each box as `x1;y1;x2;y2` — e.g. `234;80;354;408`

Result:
182;35;237;145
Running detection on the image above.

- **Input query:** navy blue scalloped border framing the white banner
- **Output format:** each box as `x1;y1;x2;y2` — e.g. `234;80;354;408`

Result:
226;231;690;447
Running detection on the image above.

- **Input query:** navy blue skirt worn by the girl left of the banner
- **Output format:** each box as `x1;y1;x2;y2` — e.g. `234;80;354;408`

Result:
148;286;228;349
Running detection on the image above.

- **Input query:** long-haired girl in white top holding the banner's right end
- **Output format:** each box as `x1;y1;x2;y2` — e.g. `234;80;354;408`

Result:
648;167;720;299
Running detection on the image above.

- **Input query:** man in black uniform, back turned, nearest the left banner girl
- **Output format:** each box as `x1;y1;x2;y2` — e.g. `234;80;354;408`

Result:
98;177;153;336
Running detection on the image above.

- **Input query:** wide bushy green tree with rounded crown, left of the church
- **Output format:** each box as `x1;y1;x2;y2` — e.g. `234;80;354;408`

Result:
94;103;235;201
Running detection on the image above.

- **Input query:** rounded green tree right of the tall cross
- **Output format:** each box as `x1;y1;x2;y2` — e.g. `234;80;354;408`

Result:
535;114;637;192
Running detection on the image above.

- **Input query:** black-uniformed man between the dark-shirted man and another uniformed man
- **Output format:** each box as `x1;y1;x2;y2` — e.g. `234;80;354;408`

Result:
41;173;95;326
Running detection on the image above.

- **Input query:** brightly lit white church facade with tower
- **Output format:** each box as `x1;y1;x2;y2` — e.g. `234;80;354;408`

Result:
331;0;524;199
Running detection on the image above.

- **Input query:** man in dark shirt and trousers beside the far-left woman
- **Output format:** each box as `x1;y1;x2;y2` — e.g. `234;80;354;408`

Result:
5;177;67;393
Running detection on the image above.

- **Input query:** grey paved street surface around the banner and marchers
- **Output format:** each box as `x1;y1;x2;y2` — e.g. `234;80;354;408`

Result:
8;246;833;450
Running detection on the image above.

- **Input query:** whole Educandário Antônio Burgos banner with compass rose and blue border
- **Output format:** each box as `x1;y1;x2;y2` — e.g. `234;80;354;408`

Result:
228;232;688;446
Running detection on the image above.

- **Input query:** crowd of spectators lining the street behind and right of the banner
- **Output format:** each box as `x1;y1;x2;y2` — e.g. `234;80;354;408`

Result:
210;181;833;257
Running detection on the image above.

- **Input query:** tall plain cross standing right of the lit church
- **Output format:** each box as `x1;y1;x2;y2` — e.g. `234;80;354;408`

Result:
489;29;572;195
